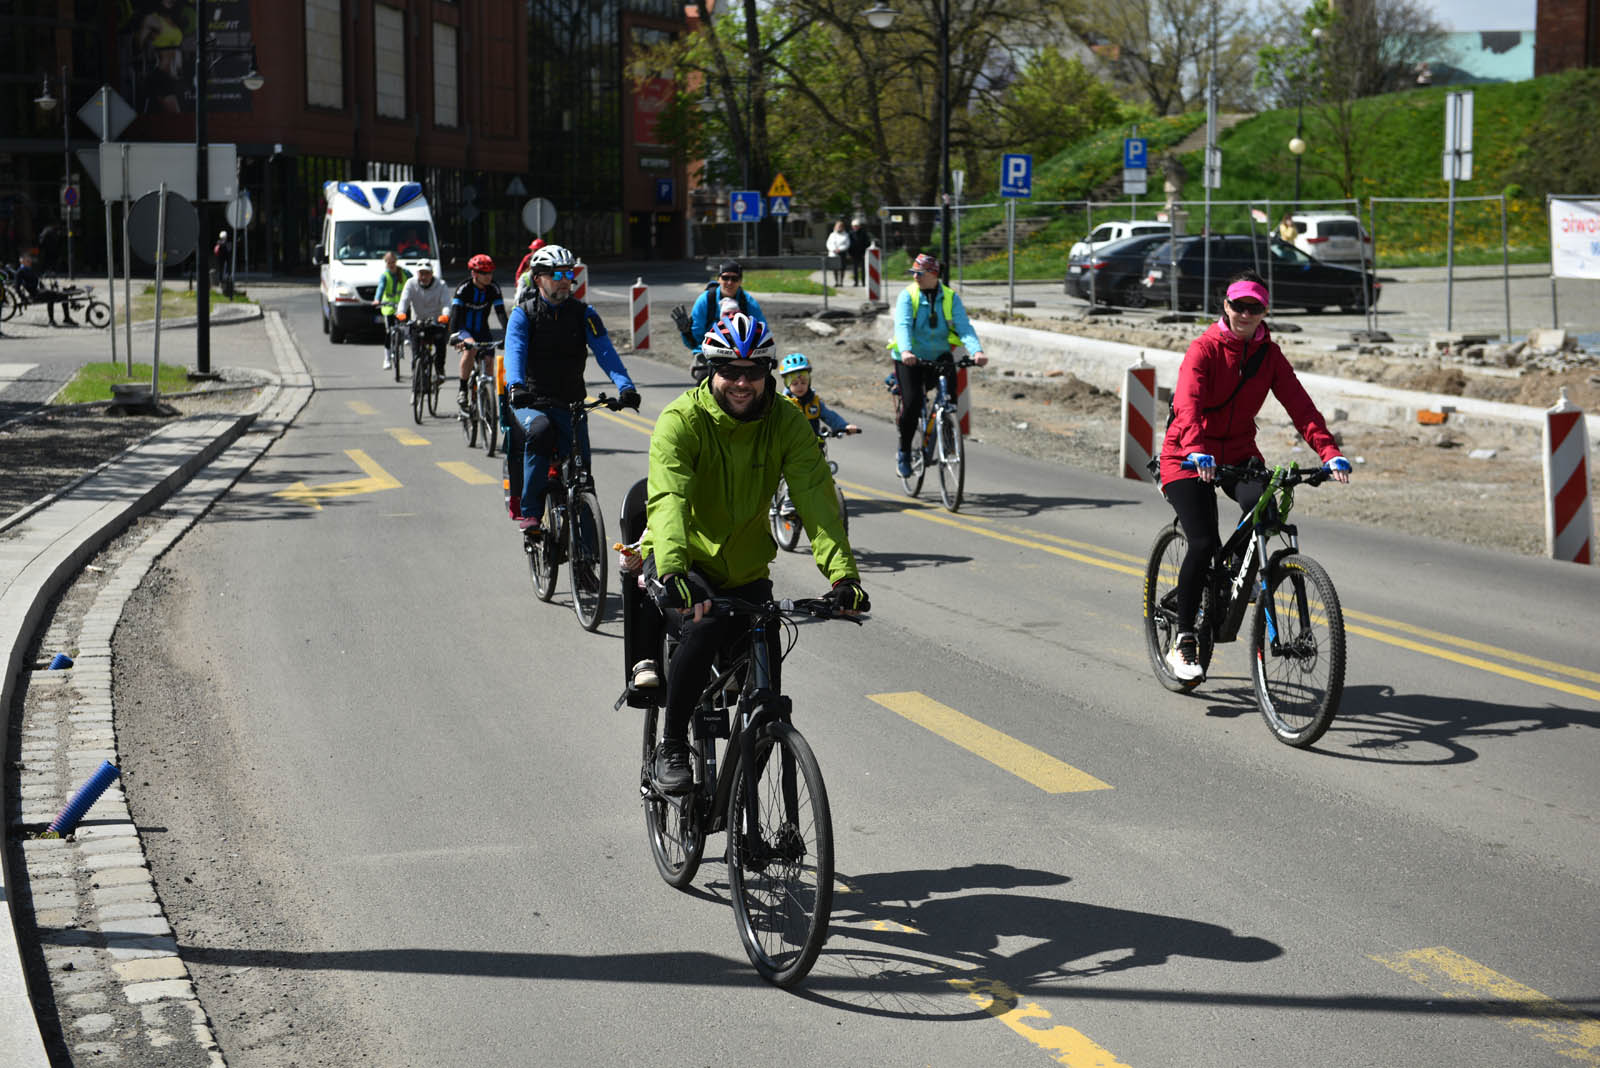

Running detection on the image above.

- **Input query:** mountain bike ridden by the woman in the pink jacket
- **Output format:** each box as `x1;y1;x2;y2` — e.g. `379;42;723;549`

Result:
1144;464;1344;748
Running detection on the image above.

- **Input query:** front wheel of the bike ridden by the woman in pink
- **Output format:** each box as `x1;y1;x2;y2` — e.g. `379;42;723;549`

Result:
1250;555;1344;748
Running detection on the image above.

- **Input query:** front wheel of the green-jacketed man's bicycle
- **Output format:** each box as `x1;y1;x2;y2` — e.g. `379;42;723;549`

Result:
728;723;834;986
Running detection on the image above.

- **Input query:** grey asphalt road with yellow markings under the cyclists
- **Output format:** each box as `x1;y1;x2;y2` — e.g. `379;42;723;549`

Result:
117;278;1600;1068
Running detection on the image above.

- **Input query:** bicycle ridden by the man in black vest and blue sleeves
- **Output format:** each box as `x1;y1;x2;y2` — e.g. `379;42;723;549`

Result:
524;393;622;632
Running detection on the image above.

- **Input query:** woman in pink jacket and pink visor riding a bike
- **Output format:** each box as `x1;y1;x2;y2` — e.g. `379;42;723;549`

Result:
1162;270;1350;679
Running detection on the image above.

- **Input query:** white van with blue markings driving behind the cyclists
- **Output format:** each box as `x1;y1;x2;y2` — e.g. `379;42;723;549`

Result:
312;182;445;344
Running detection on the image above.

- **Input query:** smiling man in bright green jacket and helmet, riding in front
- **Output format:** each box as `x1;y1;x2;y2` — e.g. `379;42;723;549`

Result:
627;313;870;791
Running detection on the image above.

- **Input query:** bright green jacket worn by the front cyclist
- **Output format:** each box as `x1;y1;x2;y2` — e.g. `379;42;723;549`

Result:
642;377;859;588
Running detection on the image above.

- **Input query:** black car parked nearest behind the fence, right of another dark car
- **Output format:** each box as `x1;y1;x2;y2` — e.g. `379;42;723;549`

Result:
1144;233;1382;313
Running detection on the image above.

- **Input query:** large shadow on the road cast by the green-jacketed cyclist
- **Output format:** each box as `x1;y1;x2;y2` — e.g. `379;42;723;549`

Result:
800;863;1283;1020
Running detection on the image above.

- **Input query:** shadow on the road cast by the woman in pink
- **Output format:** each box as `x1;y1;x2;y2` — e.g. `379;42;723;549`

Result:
1317;686;1600;764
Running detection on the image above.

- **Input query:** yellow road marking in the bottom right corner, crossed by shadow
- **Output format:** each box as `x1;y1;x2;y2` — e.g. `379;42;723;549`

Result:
1371;946;1600;1065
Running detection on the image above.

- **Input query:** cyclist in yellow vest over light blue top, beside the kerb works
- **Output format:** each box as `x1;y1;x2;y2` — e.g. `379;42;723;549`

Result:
890;253;989;478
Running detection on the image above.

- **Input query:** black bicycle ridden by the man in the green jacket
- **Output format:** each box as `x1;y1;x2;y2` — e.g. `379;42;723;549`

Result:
616;596;861;986
